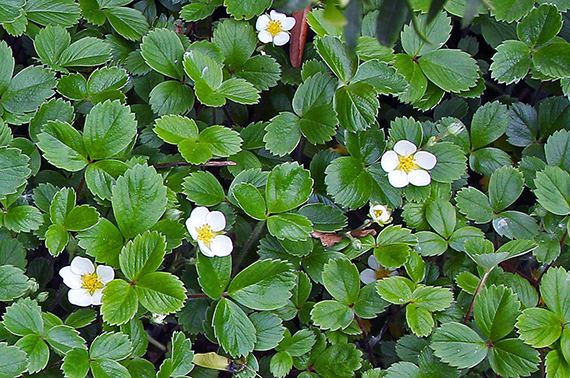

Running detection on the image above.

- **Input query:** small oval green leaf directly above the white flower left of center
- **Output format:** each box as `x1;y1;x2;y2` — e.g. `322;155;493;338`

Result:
183;171;225;206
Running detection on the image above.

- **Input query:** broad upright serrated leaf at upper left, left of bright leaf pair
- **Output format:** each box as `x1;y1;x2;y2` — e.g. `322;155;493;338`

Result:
83;100;137;160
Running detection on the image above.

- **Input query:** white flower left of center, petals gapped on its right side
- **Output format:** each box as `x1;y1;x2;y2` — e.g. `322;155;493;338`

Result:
186;207;233;257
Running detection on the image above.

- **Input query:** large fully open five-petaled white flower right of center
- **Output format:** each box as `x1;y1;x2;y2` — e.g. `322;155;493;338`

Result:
380;140;437;188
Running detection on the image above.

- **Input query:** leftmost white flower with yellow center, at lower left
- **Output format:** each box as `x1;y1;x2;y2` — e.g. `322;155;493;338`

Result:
59;256;115;307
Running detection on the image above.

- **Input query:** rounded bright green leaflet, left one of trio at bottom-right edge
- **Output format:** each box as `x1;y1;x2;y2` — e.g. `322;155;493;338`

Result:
516;307;563;348
